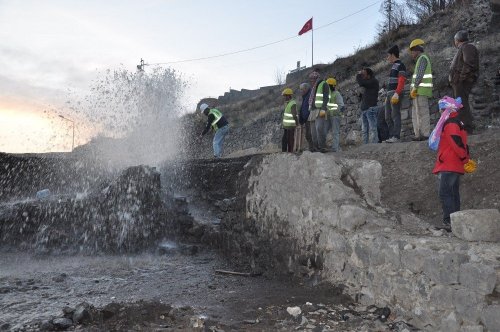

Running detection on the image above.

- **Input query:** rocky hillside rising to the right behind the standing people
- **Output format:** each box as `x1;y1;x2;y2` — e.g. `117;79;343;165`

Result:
183;0;500;158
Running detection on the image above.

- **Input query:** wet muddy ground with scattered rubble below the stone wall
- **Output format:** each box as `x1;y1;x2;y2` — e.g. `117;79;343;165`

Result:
0;248;402;331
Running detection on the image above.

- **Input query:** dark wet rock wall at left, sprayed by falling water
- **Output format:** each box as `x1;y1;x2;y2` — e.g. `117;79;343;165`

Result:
0;166;168;253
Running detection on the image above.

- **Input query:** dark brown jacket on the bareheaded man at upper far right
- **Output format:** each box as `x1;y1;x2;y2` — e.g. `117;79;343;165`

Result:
450;42;479;84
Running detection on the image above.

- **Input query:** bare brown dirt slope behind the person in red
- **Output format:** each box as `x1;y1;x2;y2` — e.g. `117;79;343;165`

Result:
342;128;500;225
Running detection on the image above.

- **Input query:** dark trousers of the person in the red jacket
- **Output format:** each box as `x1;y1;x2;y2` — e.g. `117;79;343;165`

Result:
438;172;460;224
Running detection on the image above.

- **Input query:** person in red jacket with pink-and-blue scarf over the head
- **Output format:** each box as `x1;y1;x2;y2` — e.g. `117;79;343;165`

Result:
432;97;470;230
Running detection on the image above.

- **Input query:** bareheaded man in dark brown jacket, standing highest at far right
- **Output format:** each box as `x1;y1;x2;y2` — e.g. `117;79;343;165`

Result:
449;30;479;134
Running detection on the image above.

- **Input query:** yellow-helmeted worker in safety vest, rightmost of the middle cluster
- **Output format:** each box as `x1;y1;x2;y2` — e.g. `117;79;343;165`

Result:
325;77;345;152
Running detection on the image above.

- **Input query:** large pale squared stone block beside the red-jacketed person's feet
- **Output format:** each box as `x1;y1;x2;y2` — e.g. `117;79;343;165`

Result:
450;209;500;242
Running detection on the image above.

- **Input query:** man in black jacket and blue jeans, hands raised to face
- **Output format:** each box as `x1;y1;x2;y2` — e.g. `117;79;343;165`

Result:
356;68;379;144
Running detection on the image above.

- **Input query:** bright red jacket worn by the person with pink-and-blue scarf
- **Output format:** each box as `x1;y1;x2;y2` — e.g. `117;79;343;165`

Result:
432;112;470;174
